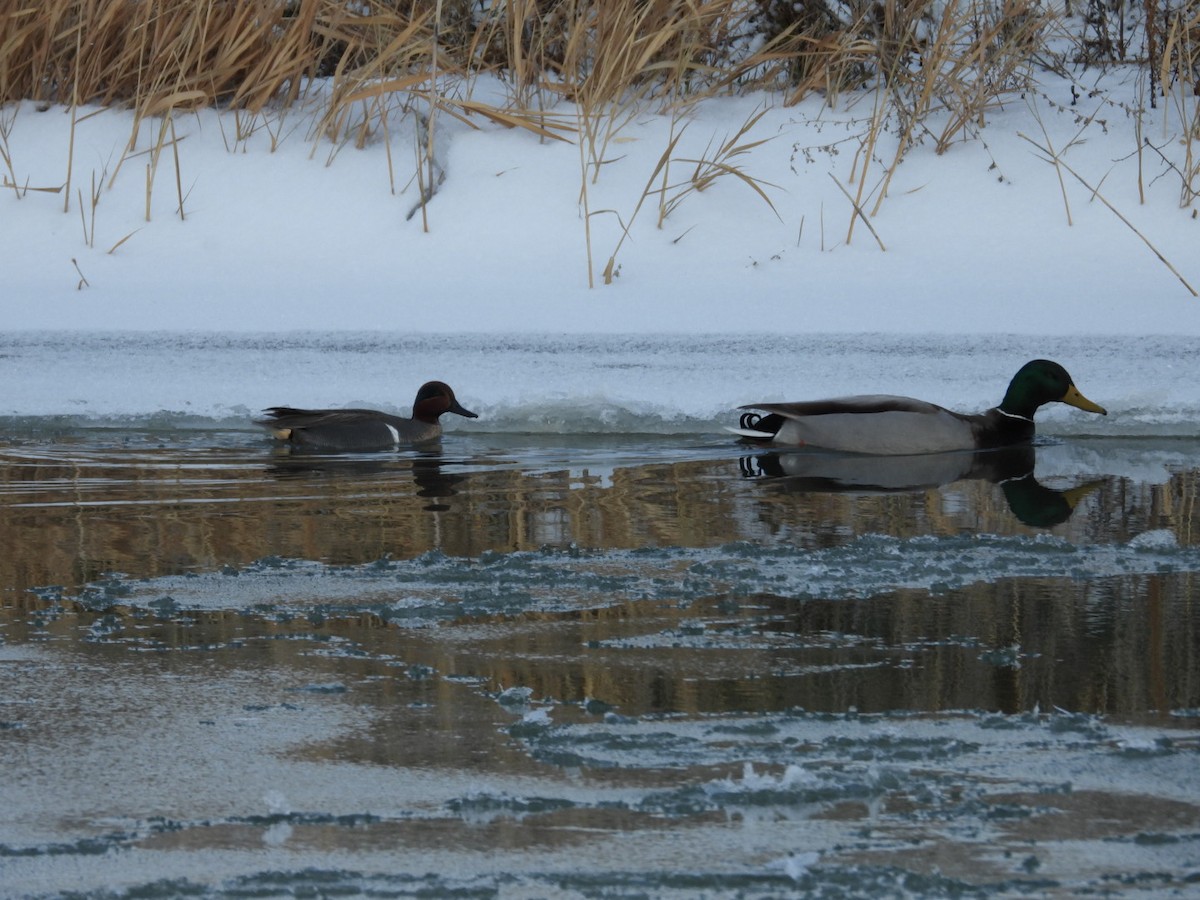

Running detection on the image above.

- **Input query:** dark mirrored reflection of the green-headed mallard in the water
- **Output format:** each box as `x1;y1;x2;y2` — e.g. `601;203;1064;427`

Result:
740;444;1102;528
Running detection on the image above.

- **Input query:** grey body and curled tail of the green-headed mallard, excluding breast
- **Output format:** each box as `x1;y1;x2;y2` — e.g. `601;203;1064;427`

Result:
739;394;978;456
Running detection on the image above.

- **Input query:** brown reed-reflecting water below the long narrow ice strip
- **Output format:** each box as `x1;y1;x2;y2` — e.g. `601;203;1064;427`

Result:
11;561;1200;724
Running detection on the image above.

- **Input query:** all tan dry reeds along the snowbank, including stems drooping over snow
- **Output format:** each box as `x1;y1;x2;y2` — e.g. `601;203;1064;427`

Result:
0;0;1180;283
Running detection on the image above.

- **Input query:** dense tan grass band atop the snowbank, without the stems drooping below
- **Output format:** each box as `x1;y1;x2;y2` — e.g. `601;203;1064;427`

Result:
0;0;1065;135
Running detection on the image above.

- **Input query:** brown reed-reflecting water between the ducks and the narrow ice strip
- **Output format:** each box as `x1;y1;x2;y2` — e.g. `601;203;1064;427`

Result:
0;448;1200;588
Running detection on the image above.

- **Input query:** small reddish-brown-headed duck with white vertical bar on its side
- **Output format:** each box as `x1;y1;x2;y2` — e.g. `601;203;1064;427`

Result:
256;382;479;450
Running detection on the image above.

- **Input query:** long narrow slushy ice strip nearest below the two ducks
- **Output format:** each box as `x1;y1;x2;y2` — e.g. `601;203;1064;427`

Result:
46;533;1200;626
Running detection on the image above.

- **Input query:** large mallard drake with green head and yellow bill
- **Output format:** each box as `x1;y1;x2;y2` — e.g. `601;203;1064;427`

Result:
730;359;1108;456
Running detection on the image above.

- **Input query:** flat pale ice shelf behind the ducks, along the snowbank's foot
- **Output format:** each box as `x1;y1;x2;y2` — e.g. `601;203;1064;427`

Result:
0;332;1200;436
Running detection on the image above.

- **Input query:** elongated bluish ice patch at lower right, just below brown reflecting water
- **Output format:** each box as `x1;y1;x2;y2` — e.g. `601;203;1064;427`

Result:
506;709;1200;805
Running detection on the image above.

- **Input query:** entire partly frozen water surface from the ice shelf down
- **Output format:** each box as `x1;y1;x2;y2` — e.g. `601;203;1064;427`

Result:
0;418;1200;898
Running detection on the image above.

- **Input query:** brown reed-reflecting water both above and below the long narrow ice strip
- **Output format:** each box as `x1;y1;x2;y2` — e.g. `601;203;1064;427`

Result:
0;451;1200;720
